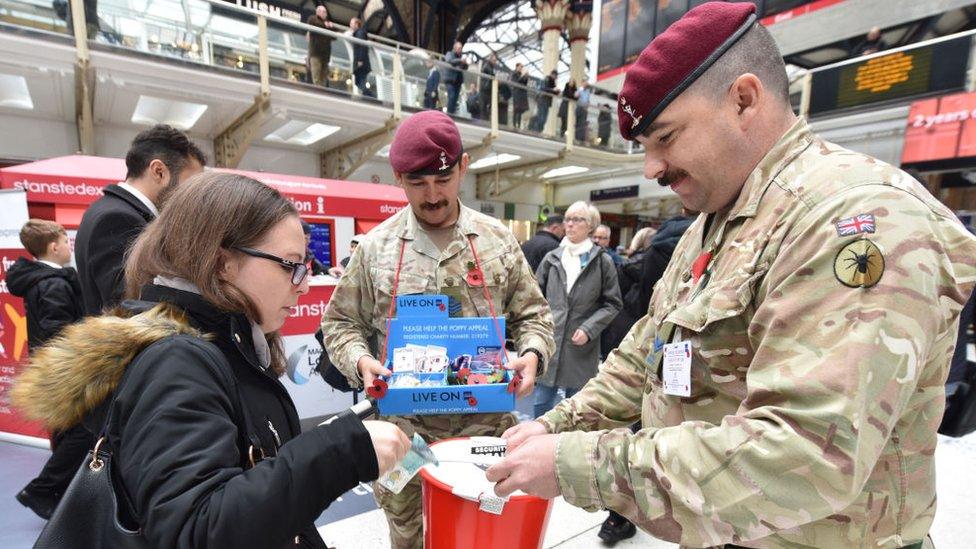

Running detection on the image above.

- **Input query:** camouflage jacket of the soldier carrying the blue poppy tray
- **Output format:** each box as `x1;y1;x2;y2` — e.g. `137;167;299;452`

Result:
322;204;554;387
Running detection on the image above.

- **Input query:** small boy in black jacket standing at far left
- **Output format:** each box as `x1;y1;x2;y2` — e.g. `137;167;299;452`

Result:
7;219;86;519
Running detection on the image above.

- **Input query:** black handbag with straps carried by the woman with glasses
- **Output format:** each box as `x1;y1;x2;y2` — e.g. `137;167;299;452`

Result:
34;340;265;549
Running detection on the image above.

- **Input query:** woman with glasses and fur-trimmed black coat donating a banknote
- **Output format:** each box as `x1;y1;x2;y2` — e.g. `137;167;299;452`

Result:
17;173;410;548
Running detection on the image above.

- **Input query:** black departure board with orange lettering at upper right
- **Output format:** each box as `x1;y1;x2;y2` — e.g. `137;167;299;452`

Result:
810;36;971;115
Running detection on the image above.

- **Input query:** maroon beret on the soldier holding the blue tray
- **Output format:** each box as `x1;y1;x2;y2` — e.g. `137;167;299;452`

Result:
390;111;462;175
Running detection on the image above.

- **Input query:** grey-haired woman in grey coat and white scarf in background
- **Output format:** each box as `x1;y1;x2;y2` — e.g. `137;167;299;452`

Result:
535;201;623;417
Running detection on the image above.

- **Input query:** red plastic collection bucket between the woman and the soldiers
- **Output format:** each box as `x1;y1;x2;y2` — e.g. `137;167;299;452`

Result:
420;438;552;549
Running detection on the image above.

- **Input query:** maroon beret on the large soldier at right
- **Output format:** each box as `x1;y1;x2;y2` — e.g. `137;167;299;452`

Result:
617;2;756;139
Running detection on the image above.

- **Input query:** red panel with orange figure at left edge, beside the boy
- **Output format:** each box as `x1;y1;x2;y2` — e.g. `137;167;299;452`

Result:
0;249;47;437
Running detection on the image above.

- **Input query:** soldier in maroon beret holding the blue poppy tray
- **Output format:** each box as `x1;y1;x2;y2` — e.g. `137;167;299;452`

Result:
322;111;554;548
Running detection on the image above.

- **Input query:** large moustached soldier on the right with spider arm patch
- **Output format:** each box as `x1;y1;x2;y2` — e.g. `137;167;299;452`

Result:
488;3;976;548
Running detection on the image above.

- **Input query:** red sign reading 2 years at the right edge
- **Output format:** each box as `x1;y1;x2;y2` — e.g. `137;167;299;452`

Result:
901;93;976;165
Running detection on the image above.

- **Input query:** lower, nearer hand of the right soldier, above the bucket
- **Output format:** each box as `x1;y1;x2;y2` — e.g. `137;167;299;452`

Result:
485;435;559;499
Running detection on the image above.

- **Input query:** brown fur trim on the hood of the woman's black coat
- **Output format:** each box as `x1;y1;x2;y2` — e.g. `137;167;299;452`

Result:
10;304;204;431
